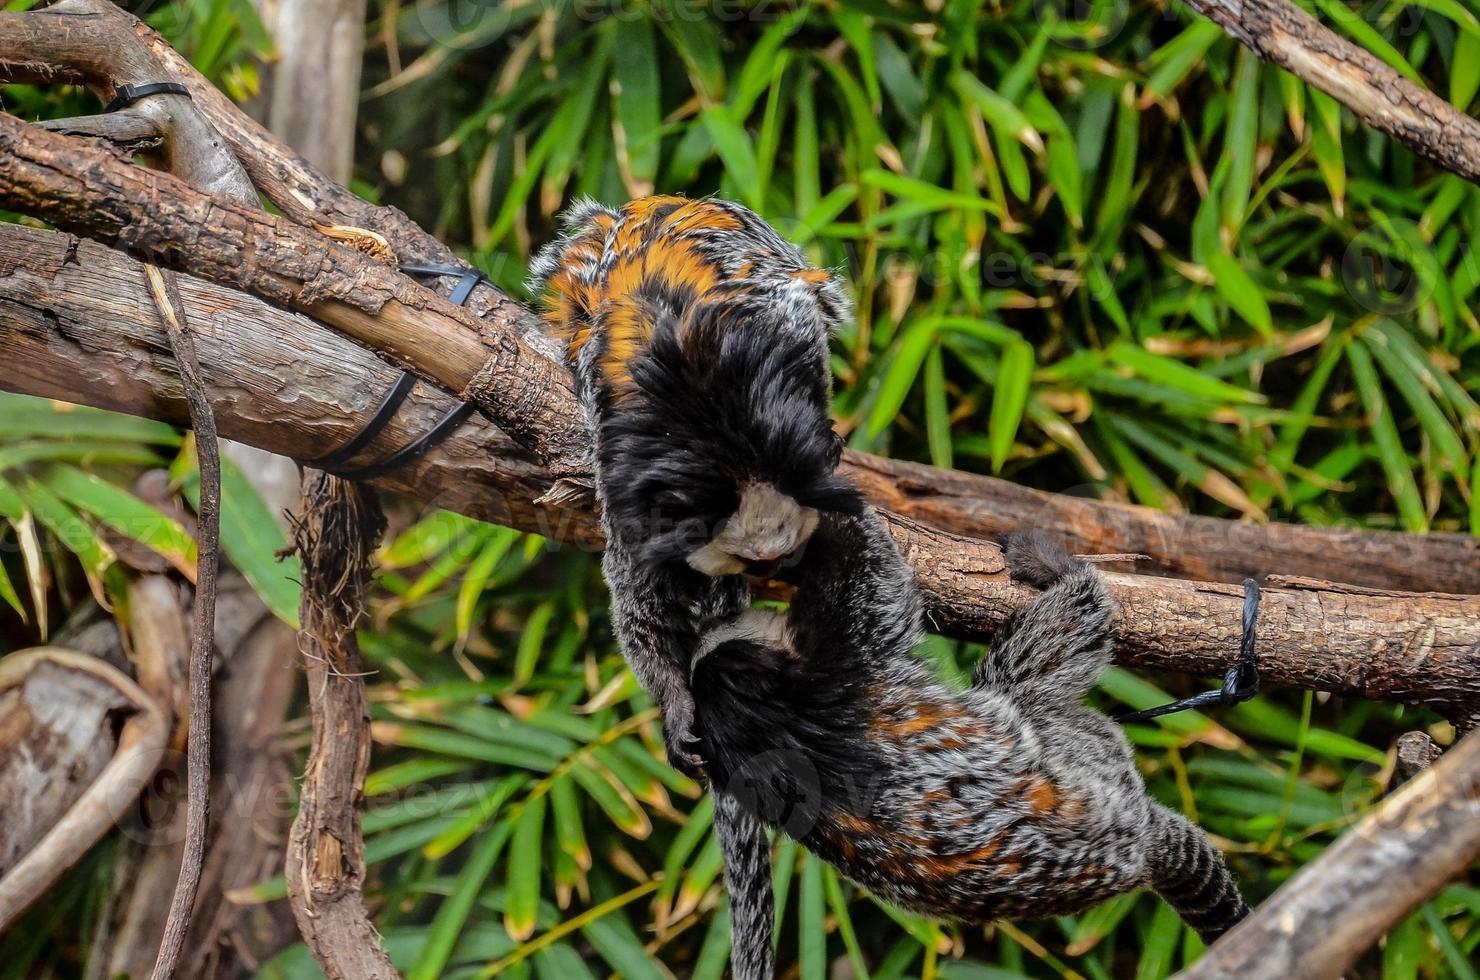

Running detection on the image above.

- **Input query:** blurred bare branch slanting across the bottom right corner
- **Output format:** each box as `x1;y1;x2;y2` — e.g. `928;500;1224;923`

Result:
1178;731;1480;980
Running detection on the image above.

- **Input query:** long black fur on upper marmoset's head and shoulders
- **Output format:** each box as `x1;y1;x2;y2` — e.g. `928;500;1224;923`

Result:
598;293;861;560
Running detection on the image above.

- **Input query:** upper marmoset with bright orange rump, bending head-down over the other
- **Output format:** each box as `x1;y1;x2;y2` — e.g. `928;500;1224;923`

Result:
531;197;860;774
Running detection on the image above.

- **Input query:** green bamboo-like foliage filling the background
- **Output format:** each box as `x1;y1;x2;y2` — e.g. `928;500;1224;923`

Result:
0;0;1480;980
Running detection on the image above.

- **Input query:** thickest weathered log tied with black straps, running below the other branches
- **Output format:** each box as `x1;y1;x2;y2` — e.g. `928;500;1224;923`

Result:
0;226;1480;725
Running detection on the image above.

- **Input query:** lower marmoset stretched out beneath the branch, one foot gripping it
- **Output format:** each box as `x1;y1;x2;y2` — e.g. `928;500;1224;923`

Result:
693;512;1248;980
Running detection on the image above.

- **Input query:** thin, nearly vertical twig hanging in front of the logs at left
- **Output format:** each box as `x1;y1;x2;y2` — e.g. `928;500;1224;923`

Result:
144;265;221;980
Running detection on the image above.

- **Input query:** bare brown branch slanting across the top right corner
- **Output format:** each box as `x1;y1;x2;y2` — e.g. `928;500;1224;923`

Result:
1185;0;1480;182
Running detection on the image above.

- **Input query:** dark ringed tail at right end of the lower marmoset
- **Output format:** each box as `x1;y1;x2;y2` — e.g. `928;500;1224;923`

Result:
1151;810;1249;943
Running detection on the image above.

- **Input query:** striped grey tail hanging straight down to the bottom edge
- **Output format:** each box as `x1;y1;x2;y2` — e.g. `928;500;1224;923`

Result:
715;792;776;980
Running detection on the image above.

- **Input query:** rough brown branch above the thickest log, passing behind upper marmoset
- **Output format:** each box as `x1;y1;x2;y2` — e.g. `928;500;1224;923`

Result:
0;103;1480;592
